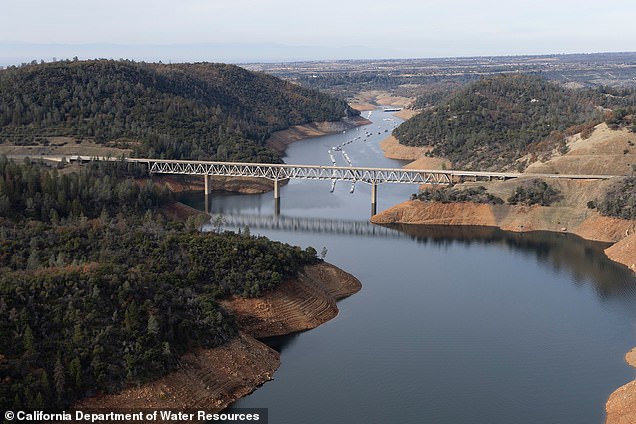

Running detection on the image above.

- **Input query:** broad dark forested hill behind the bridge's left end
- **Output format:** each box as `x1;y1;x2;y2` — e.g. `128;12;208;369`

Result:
0;60;359;162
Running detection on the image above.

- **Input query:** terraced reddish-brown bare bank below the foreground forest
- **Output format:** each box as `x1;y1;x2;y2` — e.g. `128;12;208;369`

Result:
75;262;362;412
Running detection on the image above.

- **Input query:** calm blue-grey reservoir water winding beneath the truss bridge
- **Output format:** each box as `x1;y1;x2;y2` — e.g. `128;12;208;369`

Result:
181;110;636;424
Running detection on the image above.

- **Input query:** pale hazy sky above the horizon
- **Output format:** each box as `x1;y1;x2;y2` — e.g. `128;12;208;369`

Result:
0;0;636;61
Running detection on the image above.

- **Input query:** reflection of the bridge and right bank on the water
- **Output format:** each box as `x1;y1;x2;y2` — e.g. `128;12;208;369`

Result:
196;205;636;298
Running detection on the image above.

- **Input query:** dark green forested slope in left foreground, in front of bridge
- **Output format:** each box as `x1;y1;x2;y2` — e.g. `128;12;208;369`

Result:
0;158;318;410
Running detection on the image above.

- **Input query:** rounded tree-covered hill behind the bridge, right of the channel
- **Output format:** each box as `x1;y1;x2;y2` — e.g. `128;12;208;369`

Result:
393;74;602;170
